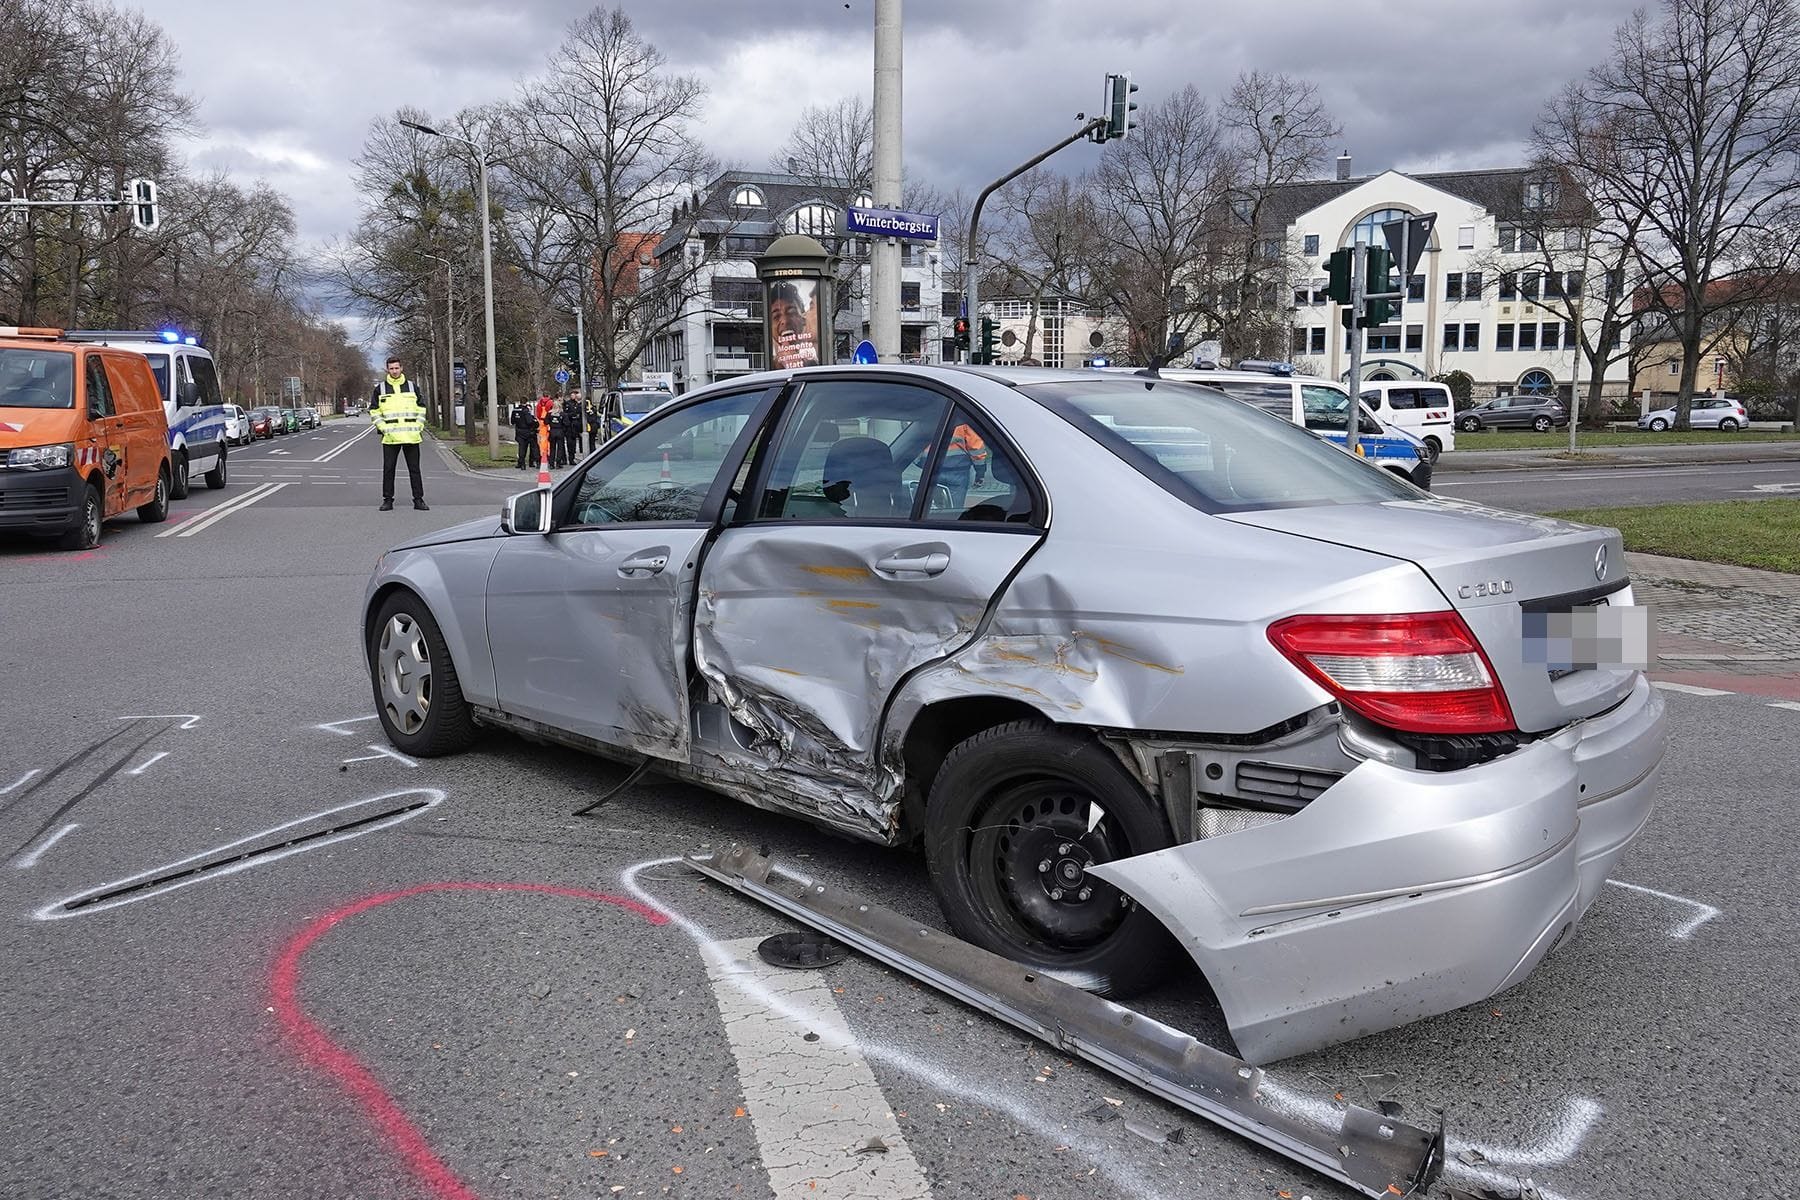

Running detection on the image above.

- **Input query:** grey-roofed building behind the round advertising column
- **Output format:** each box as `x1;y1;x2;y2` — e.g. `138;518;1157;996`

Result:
643;171;959;392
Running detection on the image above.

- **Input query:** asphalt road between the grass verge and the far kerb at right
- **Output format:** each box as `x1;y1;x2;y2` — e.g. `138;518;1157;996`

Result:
1431;450;1800;513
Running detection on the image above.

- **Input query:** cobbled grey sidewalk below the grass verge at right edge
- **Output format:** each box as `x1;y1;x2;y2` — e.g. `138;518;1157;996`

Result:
1625;551;1800;700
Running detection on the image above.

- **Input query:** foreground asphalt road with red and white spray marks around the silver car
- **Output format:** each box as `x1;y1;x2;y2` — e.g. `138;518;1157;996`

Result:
0;417;1800;1200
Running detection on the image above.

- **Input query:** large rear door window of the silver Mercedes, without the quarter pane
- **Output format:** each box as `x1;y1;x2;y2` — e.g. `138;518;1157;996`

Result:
756;380;950;522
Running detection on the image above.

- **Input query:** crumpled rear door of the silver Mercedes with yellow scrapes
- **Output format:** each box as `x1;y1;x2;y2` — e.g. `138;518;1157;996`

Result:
695;374;1046;840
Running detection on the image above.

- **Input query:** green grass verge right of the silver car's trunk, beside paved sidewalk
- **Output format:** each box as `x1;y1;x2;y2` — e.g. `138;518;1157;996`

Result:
1552;498;1800;574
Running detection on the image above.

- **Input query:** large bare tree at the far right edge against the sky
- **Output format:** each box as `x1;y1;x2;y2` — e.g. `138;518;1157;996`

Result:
1546;0;1800;428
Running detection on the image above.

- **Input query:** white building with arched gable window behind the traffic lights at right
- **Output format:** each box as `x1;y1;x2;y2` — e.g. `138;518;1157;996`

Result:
1271;157;1631;399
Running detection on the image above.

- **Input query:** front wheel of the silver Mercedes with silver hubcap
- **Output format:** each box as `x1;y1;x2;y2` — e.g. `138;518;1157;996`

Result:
367;592;475;757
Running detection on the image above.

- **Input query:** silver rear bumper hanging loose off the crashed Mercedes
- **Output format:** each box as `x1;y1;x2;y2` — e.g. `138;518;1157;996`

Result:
1089;678;1667;1061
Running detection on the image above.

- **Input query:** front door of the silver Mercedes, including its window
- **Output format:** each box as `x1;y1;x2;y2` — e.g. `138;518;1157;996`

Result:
488;389;767;761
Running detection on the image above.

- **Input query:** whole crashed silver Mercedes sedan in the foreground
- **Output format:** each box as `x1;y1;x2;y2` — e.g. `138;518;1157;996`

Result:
358;367;1665;1060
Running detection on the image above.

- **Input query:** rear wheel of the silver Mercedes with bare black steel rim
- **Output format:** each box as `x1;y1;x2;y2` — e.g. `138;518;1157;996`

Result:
925;721;1181;997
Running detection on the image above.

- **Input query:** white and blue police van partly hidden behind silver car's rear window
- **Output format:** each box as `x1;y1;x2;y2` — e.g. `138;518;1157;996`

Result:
1112;362;1431;488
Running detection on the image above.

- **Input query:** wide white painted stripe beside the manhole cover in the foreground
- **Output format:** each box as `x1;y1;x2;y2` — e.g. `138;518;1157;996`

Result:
706;937;931;1200
